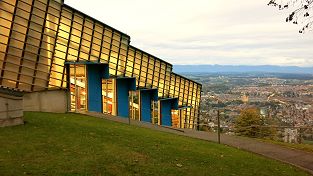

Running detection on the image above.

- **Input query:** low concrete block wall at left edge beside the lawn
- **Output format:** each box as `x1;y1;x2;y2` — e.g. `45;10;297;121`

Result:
0;93;23;127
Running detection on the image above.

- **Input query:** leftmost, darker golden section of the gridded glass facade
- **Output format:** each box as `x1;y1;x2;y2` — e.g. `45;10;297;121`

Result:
0;0;61;91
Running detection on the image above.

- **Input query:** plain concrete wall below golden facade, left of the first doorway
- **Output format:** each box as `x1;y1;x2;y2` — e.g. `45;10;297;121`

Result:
23;90;68;113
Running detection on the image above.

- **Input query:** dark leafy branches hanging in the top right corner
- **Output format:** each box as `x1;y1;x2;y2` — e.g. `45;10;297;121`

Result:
267;0;313;33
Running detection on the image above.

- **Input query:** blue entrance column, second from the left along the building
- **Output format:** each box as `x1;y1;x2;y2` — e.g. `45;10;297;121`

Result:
116;77;136;117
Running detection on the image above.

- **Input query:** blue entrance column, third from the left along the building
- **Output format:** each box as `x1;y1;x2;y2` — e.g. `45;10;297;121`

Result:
139;89;158;123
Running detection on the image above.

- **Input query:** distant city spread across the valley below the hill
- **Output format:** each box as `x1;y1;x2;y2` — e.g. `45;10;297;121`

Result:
179;69;313;143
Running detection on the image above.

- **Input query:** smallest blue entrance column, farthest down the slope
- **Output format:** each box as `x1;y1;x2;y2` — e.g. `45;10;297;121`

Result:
159;98;178;126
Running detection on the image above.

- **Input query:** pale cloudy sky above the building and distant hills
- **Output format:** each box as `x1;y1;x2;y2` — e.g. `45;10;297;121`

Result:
65;0;313;67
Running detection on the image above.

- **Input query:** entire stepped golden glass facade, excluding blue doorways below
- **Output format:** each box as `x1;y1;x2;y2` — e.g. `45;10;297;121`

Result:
0;0;201;128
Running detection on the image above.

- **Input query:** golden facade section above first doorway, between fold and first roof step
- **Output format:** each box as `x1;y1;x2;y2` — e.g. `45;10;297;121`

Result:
49;5;130;87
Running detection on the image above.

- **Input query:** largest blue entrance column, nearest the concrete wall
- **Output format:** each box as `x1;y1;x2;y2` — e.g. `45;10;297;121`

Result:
86;63;109;112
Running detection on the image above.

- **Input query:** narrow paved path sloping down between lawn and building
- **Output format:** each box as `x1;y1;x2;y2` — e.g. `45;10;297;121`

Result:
83;112;313;175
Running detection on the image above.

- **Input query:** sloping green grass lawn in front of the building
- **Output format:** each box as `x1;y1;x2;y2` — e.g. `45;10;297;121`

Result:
0;112;307;176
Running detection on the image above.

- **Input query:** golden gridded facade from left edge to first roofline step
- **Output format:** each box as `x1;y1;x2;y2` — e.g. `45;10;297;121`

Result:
0;0;130;91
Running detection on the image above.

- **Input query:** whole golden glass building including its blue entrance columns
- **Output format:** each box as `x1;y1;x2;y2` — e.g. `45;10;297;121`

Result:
0;0;201;128
